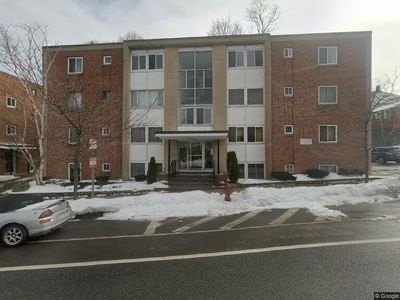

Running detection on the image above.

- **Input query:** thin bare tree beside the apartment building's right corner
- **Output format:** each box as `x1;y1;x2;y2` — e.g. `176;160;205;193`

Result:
364;69;400;183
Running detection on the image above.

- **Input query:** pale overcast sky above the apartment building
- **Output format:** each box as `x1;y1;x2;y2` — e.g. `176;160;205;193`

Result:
0;0;400;79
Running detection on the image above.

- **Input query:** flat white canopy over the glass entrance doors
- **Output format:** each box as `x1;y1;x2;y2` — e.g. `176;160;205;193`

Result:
155;130;228;141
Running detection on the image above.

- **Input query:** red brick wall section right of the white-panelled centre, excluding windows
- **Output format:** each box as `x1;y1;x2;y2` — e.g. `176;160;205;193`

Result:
271;38;370;173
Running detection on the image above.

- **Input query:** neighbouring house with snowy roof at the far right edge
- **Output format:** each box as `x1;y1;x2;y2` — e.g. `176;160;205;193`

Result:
372;87;400;147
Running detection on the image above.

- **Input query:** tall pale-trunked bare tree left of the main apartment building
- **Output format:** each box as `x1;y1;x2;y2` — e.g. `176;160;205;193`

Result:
0;24;53;185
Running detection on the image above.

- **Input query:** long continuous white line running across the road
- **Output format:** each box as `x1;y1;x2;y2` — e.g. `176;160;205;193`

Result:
4;238;400;273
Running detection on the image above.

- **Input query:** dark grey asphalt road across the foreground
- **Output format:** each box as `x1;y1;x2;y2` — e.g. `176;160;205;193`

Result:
0;220;400;299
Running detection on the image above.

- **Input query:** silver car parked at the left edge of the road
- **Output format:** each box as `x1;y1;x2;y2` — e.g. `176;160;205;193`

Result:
0;194;73;247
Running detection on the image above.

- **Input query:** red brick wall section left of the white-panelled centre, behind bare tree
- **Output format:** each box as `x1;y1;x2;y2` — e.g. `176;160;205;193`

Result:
47;48;123;179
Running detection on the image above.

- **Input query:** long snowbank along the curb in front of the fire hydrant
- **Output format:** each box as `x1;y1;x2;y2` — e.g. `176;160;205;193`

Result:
69;178;400;220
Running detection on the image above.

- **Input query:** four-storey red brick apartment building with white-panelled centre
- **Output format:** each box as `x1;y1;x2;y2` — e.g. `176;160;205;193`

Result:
45;32;371;179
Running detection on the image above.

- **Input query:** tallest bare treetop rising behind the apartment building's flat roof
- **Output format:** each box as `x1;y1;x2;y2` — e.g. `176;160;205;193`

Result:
246;0;280;33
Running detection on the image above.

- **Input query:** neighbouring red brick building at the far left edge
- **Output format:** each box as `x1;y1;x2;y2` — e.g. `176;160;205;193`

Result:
0;71;36;175
